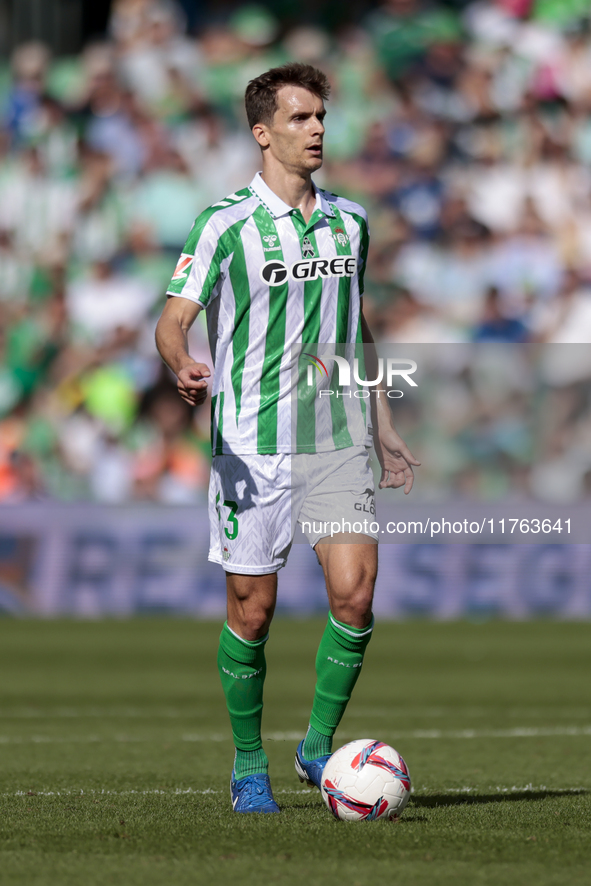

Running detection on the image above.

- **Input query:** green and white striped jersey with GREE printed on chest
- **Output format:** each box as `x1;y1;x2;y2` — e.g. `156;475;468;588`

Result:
168;173;371;455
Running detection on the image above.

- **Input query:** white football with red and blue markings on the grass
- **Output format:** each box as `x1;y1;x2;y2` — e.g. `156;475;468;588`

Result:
321;738;410;821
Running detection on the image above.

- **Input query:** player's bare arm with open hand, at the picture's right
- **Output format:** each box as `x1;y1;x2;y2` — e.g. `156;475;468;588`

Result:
360;299;421;495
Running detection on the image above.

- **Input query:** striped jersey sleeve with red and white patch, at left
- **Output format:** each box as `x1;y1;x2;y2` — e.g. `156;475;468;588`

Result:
166;210;222;308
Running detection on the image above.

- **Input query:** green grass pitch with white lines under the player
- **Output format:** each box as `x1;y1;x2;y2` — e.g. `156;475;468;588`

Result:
0;620;591;886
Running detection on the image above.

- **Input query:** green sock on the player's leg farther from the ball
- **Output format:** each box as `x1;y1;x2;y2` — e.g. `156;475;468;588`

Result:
218;622;269;779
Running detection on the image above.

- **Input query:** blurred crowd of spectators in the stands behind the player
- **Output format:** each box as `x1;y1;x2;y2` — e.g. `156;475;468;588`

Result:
0;0;591;504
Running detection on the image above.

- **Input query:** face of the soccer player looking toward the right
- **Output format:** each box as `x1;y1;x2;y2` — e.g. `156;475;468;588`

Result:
259;86;326;173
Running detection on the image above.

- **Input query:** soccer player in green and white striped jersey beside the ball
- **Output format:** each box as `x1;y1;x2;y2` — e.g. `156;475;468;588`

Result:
156;63;419;812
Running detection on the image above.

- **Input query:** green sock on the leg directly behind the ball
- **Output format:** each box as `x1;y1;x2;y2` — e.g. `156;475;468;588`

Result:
303;612;373;760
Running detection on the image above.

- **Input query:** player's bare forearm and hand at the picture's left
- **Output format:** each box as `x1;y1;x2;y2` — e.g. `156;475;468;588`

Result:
156;296;211;406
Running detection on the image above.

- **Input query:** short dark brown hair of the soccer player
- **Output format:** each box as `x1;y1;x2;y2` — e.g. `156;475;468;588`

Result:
244;62;330;129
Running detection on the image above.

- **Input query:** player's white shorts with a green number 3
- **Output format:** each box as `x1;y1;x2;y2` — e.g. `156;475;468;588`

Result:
209;446;378;575
